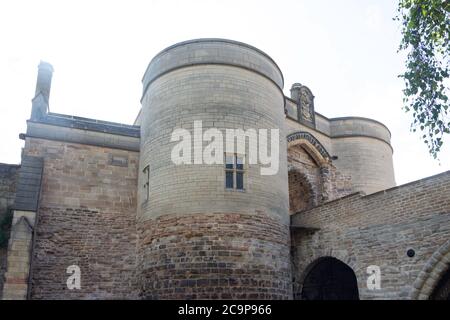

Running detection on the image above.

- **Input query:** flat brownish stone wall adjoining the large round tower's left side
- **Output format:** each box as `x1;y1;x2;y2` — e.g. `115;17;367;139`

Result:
25;138;139;299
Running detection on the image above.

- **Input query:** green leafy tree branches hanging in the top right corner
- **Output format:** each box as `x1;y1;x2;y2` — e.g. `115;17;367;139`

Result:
395;0;450;158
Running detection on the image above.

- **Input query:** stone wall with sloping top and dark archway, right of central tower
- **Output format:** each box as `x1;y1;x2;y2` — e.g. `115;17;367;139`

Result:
292;171;450;299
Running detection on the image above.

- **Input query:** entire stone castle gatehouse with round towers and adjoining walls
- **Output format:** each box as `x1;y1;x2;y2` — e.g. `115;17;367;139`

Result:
0;39;450;299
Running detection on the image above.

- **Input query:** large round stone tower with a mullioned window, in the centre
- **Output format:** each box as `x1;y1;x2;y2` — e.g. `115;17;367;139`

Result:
138;39;292;299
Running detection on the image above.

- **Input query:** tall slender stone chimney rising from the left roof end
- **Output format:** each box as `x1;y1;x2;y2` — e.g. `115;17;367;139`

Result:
30;61;53;120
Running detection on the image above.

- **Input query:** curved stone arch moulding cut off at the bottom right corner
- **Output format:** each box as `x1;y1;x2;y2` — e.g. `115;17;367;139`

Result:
410;240;450;300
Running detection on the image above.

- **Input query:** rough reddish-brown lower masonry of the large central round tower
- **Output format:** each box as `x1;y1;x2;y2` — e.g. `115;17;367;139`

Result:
138;212;292;299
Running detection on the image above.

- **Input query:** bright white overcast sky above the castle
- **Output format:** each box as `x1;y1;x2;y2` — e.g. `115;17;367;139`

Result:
0;0;450;184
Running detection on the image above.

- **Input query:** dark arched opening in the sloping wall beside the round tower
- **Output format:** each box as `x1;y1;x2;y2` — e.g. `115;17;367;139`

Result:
301;257;359;300
